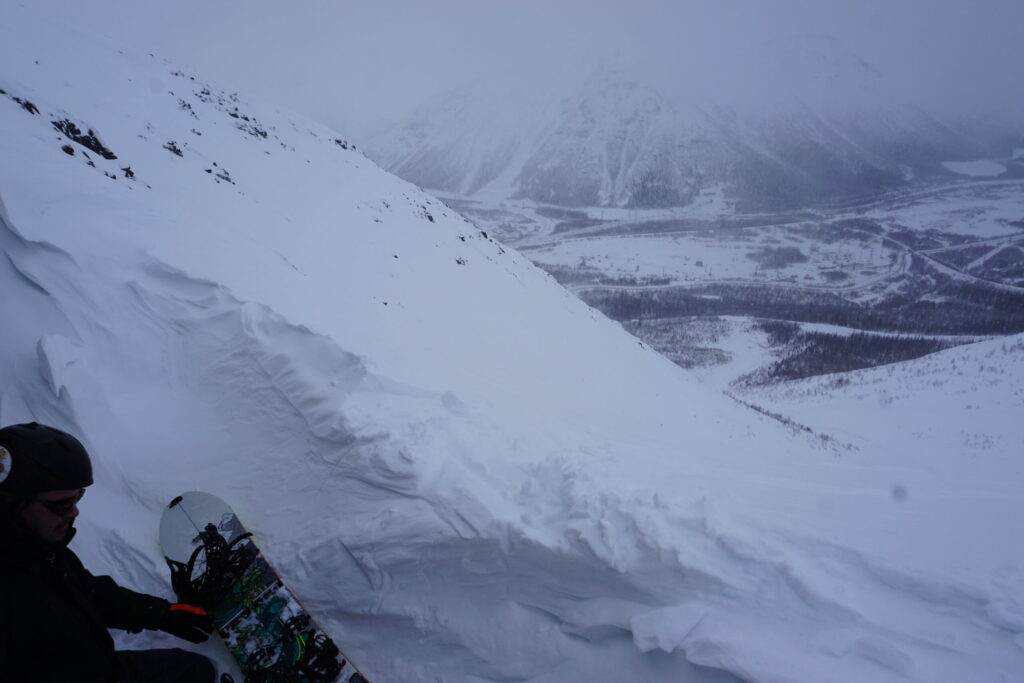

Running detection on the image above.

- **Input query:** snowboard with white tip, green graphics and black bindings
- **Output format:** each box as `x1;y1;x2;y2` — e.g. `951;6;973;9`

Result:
160;492;369;683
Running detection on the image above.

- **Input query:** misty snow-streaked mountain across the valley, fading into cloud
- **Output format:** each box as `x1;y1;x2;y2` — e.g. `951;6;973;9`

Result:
364;39;1013;208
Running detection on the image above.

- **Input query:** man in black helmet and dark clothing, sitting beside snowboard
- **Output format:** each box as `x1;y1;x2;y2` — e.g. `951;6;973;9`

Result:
0;422;216;683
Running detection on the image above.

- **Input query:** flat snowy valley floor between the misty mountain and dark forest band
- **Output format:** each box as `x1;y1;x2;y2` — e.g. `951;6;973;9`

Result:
458;181;1024;293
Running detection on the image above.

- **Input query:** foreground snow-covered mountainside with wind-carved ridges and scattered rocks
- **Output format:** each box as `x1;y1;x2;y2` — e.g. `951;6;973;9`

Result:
0;2;1024;683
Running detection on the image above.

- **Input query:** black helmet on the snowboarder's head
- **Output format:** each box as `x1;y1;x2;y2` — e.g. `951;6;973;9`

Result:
0;422;92;500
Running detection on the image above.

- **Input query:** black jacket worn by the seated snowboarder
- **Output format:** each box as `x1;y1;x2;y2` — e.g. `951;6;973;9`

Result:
0;508;169;683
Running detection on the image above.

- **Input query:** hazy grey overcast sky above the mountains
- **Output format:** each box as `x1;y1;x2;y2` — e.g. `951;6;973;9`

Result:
24;0;1024;140
